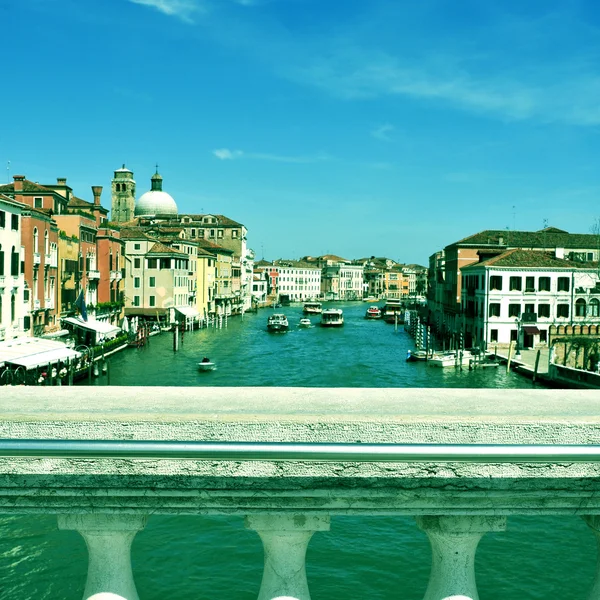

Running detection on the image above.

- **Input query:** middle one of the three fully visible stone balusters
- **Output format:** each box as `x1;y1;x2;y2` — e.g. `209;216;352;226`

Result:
246;514;329;600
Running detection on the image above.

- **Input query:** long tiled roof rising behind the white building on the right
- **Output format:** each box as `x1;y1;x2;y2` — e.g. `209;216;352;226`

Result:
446;227;598;248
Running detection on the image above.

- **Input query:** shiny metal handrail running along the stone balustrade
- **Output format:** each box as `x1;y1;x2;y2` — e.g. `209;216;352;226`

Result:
0;439;600;463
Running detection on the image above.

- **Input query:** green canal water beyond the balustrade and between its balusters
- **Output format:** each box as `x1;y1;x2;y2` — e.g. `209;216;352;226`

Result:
0;303;596;600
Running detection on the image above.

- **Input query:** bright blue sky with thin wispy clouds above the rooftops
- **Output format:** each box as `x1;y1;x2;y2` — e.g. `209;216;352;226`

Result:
0;0;600;264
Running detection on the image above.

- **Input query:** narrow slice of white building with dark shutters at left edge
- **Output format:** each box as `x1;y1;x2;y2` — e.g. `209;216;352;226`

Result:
0;194;28;341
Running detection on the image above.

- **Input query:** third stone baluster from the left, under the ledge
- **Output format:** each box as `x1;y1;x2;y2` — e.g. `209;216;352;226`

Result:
417;516;506;600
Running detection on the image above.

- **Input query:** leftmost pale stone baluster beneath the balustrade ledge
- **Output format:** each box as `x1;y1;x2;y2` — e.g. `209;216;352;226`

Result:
58;514;146;600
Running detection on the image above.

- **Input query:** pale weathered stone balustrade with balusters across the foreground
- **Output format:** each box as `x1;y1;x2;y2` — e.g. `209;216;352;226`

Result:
0;387;600;600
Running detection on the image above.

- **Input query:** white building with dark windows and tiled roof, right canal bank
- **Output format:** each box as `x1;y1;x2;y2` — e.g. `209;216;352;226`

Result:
461;249;600;348
